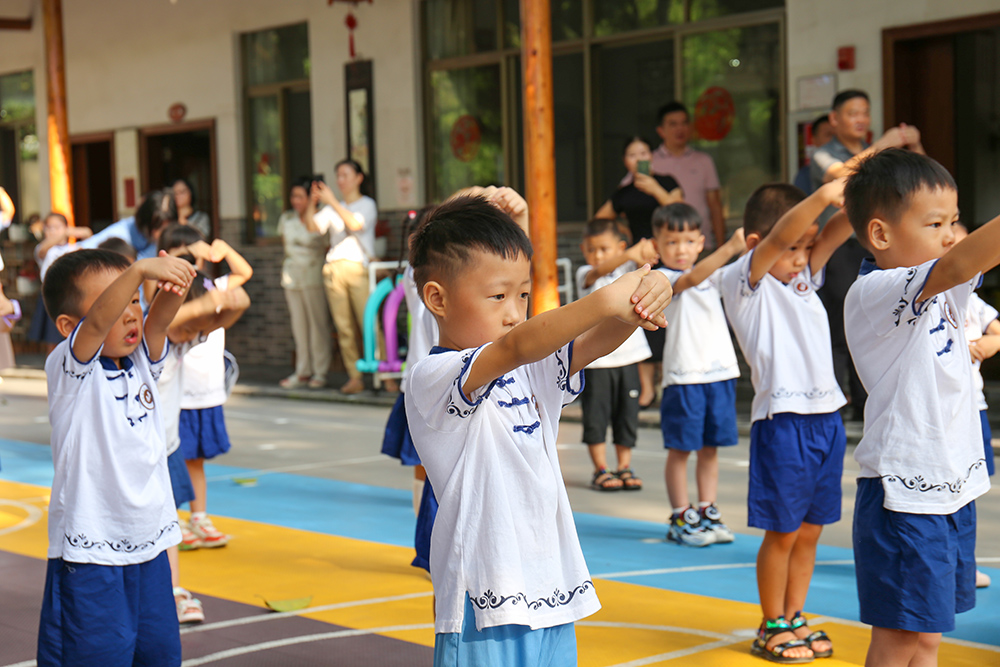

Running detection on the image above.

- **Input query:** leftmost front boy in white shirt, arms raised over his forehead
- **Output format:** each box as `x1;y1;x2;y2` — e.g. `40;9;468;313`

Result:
38;250;194;667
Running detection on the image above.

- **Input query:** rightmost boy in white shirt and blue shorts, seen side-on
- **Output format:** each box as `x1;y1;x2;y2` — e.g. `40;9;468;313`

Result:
844;149;1000;667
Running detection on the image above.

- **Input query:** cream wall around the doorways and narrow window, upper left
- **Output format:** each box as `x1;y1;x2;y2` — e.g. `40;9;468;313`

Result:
0;0;423;218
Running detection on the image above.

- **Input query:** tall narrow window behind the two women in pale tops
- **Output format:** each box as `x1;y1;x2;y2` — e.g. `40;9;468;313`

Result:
241;23;313;240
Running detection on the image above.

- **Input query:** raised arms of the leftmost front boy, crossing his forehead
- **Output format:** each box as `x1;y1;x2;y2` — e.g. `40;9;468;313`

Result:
73;253;195;360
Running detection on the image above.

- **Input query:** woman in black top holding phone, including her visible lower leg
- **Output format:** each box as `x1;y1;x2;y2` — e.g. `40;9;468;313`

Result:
594;137;684;409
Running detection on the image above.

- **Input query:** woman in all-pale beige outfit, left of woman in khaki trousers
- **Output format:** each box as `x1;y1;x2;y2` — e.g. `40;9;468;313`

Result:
278;178;332;389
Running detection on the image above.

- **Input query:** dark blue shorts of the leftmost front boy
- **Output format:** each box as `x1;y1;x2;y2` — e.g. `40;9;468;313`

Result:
38;552;181;667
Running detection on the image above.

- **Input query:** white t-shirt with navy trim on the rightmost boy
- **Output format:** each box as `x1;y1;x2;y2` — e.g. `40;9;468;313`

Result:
844;260;990;514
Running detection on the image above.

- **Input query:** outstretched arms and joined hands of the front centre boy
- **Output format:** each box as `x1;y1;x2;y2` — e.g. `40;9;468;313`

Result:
462;264;670;396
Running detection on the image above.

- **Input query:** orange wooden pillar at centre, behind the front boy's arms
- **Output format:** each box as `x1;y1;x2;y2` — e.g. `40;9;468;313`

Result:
521;0;559;314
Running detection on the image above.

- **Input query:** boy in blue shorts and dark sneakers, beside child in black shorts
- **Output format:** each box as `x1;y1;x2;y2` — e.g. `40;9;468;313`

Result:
653;203;746;547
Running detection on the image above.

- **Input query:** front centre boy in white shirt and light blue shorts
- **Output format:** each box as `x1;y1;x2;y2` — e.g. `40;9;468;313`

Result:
406;197;670;667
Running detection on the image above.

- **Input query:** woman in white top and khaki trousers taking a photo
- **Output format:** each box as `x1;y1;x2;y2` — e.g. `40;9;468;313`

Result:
302;160;378;394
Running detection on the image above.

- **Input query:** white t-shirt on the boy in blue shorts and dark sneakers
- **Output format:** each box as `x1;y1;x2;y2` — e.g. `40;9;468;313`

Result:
660;267;740;387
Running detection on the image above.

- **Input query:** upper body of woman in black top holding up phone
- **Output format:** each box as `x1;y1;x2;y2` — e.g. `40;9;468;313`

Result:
594;137;684;242
